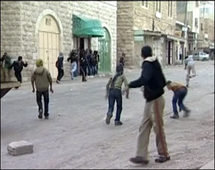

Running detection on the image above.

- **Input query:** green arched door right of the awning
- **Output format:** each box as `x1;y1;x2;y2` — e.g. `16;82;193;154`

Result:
99;28;111;73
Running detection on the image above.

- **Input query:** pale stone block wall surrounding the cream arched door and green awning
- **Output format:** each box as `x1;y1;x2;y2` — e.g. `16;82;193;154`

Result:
1;1;116;81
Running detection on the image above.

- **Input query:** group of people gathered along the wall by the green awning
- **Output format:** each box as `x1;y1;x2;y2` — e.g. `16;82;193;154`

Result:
56;49;99;83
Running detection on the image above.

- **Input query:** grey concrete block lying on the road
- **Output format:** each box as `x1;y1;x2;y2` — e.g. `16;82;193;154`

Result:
7;140;33;156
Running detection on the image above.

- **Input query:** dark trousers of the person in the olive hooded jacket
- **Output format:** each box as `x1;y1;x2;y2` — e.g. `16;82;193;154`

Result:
36;90;49;116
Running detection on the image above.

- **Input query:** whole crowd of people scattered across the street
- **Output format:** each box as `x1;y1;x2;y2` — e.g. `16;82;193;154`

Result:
1;46;196;164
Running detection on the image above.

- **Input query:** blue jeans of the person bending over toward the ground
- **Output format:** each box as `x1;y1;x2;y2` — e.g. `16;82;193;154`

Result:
172;88;188;114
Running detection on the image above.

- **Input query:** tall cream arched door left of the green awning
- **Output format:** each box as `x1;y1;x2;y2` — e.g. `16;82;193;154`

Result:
38;15;60;77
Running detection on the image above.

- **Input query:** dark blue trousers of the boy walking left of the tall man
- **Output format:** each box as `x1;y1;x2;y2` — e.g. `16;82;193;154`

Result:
107;89;122;121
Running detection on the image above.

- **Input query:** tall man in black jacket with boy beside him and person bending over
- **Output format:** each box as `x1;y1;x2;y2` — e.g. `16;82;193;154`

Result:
105;46;193;164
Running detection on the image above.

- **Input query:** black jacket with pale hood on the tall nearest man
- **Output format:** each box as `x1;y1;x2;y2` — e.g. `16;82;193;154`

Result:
129;57;166;102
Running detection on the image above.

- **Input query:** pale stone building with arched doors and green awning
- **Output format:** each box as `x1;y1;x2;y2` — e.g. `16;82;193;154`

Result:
1;1;117;81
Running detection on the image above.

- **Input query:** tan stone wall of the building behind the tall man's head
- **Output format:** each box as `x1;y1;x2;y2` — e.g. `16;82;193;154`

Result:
117;1;176;66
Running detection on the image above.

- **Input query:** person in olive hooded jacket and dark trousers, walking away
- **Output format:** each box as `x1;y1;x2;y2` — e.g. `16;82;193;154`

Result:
31;59;53;119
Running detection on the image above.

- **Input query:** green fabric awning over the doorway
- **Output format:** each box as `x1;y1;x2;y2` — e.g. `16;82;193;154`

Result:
72;15;104;37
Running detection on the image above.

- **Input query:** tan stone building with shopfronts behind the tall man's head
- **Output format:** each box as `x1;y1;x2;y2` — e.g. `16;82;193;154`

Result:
117;1;176;67
